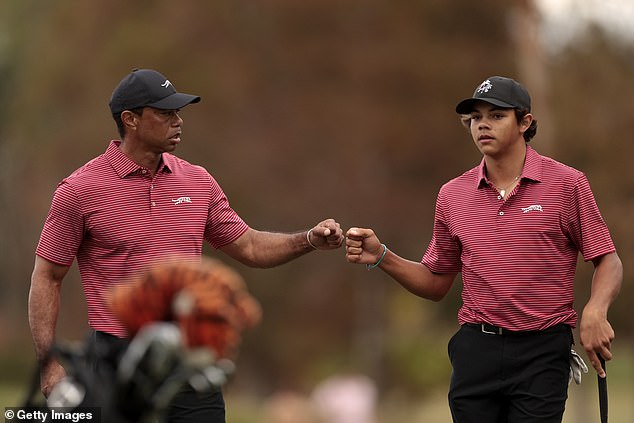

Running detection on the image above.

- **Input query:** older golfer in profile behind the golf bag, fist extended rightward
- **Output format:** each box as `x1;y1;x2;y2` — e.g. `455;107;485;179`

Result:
29;69;344;422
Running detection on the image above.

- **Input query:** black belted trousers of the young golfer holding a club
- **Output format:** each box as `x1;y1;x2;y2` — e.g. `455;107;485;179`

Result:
448;325;573;423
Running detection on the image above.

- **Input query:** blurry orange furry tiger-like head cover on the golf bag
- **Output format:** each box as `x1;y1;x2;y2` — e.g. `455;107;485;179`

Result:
109;257;261;358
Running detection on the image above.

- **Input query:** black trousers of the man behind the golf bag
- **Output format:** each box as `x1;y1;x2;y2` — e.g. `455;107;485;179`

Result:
89;332;226;423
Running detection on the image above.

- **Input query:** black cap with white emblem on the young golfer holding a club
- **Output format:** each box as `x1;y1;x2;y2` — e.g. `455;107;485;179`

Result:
456;76;531;115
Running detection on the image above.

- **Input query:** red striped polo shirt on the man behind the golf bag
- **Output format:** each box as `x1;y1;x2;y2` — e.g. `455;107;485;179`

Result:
36;141;248;337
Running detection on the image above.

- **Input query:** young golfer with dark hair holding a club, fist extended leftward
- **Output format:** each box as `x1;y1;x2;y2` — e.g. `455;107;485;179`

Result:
346;76;622;423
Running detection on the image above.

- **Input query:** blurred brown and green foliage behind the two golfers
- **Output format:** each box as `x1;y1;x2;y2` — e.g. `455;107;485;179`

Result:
0;0;634;422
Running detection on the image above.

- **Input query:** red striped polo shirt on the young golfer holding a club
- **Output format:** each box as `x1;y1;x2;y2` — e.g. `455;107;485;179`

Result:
421;146;615;330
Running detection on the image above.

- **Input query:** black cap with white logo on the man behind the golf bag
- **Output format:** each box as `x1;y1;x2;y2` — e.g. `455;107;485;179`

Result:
110;69;200;115
